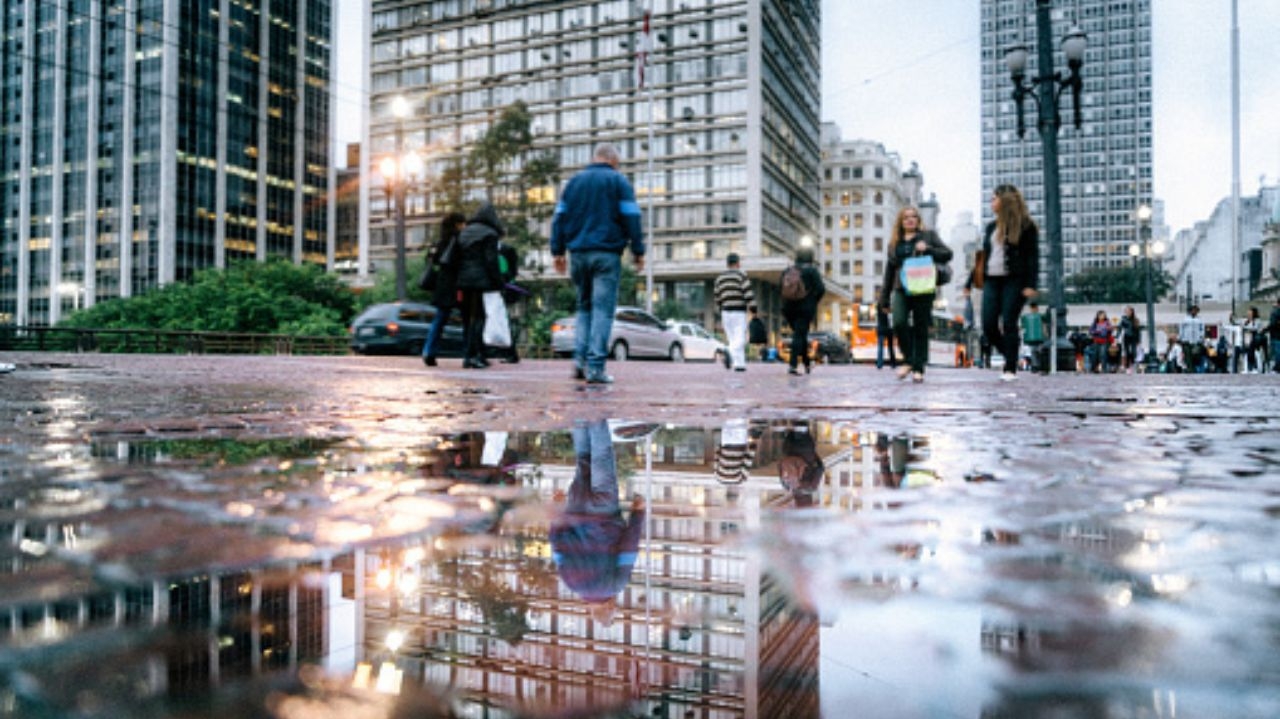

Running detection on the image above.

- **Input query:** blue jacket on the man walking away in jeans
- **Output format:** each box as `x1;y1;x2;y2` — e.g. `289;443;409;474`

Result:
552;162;645;257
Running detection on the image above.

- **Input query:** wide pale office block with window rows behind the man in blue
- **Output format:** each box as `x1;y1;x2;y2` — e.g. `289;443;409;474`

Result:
362;0;820;325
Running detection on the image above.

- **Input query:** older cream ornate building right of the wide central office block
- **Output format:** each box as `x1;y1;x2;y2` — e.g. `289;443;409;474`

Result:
818;123;946;316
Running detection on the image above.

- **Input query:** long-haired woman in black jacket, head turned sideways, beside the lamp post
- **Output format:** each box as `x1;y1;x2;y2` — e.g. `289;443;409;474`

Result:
964;184;1039;380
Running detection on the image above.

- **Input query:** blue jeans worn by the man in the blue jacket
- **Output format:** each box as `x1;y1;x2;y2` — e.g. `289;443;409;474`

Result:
568;251;622;379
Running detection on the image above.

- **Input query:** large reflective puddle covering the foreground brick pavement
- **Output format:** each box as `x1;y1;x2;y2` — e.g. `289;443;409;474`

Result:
0;412;1280;718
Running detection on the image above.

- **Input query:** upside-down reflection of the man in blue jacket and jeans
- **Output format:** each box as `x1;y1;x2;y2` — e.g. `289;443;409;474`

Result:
550;420;645;626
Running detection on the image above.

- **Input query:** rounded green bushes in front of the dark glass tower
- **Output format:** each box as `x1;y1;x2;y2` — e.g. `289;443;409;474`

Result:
60;258;356;336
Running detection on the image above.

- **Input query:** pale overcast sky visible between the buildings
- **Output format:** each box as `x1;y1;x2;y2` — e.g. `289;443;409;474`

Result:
337;0;1280;237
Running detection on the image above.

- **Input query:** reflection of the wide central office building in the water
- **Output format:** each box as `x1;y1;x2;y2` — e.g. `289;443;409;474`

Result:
356;422;819;718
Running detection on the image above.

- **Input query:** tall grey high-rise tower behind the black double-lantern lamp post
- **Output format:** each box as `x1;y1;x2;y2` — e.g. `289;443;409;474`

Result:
979;0;1152;280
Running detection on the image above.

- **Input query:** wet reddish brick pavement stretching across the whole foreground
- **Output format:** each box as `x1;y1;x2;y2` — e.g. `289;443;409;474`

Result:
0;353;1280;718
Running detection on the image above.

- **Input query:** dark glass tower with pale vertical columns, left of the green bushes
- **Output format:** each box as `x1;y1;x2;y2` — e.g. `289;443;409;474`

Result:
0;0;333;325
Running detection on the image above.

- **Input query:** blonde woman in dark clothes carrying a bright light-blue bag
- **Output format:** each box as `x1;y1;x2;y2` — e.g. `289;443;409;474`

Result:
879;205;952;383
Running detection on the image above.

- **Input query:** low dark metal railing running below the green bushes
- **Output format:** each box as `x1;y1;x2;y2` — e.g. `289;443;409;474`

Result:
0;325;351;354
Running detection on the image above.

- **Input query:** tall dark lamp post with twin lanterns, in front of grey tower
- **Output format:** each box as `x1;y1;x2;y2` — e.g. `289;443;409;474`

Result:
1005;0;1085;372
